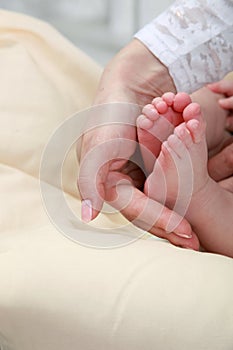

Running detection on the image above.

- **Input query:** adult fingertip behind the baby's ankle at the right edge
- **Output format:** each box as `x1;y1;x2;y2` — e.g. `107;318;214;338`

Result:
208;138;233;181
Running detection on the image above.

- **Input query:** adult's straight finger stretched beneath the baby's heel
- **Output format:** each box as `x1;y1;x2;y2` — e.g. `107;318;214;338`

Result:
106;172;199;250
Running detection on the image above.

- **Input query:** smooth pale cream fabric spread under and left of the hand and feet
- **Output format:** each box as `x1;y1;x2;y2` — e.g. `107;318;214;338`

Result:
0;11;233;350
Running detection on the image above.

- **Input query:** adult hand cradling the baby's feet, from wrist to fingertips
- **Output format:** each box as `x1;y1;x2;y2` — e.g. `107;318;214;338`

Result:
78;40;199;249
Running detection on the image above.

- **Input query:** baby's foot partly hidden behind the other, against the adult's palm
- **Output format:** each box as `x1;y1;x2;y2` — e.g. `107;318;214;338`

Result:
137;92;191;172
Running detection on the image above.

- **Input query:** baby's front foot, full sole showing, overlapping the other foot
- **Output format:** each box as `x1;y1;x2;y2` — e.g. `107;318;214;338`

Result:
144;103;209;230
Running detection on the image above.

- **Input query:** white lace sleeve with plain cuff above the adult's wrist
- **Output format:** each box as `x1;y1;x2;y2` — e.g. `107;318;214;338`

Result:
135;0;233;93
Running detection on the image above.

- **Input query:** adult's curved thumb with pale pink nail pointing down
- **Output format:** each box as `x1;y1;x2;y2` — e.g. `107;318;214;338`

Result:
78;129;136;222
